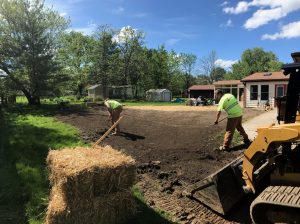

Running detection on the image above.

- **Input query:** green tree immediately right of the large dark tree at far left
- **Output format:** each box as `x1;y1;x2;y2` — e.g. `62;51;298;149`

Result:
58;31;93;97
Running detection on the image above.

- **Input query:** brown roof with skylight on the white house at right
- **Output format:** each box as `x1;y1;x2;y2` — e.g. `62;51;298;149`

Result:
241;71;290;82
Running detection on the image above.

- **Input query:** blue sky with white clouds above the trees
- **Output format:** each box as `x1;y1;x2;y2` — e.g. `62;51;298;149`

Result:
45;0;300;70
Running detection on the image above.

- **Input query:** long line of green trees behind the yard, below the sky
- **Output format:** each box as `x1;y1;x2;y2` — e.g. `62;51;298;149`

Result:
0;0;282;105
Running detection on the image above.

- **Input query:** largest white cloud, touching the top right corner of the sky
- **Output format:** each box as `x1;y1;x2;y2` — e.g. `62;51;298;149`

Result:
223;0;300;30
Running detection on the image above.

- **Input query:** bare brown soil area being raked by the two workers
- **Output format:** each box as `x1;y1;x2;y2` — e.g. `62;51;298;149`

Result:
57;106;263;223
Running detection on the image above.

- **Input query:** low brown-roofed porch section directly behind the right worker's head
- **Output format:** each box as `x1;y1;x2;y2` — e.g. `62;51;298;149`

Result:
213;80;244;101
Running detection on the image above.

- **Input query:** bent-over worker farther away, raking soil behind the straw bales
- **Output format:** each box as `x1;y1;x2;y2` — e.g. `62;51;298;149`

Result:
104;99;123;135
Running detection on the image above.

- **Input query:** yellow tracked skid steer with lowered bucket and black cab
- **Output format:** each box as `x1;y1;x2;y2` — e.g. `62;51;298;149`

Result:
185;52;300;223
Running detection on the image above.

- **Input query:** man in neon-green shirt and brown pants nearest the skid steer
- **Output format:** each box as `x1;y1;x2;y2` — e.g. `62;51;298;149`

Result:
215;90;251;151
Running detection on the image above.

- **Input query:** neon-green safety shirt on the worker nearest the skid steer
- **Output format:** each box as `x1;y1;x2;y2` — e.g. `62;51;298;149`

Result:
218;93;243;118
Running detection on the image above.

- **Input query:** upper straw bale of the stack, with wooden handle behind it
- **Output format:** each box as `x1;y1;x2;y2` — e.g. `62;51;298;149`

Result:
47;146;136;200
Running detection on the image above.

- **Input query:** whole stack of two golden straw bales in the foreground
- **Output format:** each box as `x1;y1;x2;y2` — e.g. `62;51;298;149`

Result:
46;146;136;224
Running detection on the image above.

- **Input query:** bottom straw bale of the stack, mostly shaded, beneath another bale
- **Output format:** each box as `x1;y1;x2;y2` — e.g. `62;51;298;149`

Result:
46;188;136;224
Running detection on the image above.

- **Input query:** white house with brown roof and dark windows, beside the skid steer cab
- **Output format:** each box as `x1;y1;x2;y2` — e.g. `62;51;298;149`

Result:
241;72;289;107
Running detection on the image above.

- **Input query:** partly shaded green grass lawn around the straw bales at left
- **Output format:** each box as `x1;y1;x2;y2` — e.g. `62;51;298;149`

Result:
0;104;170;224
